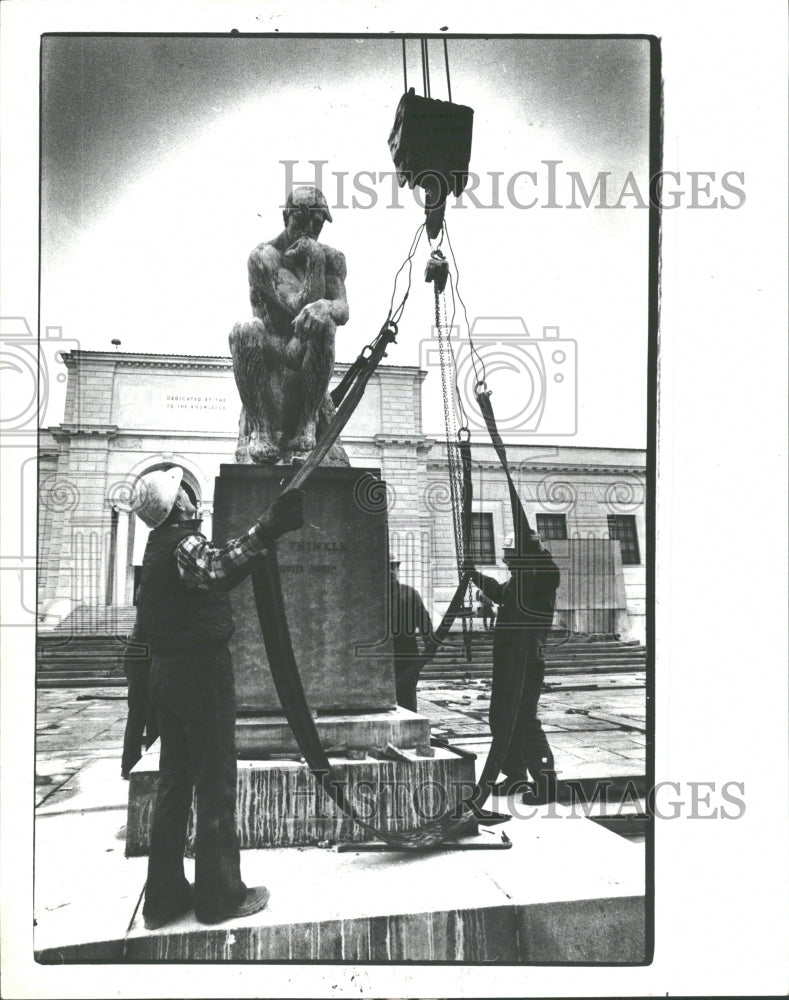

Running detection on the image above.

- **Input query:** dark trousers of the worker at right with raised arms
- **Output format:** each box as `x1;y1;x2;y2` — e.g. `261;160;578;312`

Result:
490;625;553;779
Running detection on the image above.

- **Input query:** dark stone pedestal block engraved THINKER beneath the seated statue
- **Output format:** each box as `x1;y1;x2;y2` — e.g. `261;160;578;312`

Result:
214;465;395;732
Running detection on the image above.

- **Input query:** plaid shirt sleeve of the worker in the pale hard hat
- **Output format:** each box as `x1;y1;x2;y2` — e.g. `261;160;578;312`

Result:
175;524;269;590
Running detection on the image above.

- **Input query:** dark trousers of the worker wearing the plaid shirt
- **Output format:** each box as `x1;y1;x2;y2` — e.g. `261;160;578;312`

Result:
143;646;246;920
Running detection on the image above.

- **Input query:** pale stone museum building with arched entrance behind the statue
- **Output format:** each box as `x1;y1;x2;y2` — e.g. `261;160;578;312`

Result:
38;350;647;642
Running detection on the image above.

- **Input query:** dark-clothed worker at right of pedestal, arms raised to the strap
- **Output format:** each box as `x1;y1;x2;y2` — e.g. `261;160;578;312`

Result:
465;534;560;802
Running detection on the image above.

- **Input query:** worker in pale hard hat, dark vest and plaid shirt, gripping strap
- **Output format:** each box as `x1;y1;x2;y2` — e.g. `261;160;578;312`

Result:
135;468;303;930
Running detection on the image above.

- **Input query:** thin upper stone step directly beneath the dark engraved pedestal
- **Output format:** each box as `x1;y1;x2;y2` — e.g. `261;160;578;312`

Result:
236;706;430;760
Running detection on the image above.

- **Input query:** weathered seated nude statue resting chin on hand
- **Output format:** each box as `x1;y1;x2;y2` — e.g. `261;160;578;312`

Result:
230;186;349;465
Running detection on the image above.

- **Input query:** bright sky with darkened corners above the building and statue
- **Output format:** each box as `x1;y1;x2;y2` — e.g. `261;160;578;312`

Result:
41;37;649;448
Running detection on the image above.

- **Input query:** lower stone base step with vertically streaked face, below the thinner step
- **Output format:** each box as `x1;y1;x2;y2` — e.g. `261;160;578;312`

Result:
126;744;474;856
